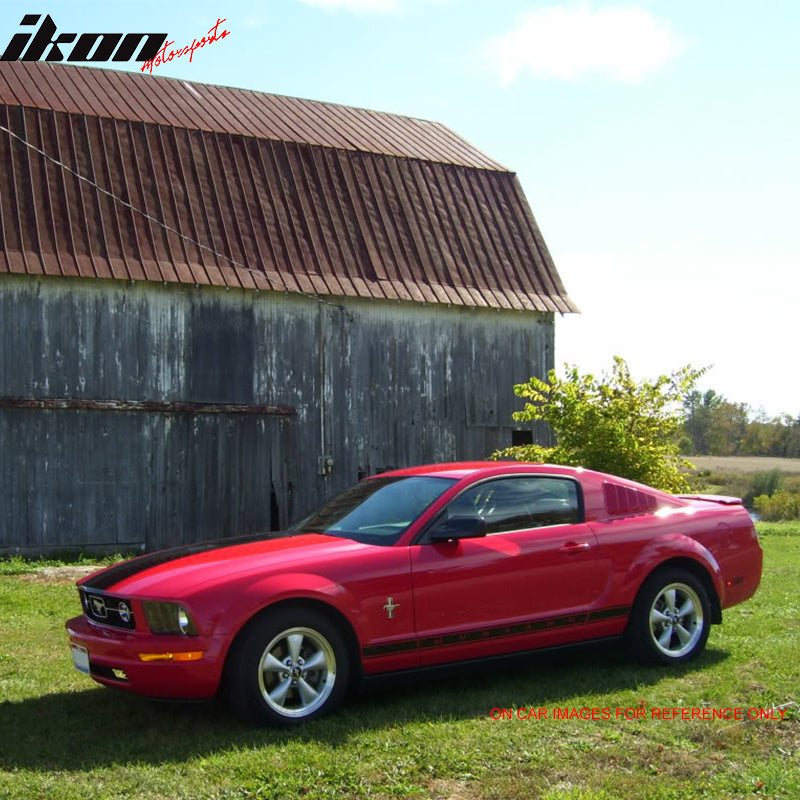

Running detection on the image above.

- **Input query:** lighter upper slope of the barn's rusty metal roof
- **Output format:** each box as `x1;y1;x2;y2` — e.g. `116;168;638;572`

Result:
0;61;504;169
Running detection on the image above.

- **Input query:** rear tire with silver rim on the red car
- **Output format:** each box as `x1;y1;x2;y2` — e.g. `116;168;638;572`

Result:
627;568;711;664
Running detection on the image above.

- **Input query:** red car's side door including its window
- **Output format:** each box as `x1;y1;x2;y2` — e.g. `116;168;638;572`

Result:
411;474;609;664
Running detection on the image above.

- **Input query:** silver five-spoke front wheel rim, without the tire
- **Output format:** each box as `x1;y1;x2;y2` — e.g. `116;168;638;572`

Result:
258;628;336;717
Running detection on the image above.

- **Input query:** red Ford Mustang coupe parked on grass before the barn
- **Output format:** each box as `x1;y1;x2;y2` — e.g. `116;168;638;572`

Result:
67;462;761;725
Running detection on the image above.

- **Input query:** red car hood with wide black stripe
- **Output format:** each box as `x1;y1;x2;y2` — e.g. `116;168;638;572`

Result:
78;533;370;596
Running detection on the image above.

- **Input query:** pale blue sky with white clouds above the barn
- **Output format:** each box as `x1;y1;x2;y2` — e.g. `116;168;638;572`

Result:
0;0;800;416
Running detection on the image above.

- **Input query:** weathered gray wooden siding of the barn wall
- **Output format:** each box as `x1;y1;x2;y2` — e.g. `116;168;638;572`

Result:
0;276;553;553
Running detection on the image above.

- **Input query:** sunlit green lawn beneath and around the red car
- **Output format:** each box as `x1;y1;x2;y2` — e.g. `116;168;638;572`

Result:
0;523;800;800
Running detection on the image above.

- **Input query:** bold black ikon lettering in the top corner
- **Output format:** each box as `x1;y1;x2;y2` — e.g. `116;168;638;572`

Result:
0;14;167;62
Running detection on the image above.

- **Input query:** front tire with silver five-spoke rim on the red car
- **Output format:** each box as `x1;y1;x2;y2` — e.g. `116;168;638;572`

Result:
226;607;350;727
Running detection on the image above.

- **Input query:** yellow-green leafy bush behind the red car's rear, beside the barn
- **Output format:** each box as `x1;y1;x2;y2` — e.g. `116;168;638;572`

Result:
492;356;705;492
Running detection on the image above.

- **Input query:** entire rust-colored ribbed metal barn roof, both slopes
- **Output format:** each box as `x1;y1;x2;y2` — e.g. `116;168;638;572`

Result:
0;62;576;312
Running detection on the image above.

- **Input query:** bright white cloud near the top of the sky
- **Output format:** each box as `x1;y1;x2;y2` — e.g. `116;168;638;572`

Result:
483;4;683;84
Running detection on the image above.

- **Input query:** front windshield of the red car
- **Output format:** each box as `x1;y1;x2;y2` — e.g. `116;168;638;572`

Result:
291;475;455;545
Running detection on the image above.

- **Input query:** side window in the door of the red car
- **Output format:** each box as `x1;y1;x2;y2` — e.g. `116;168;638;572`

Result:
445;475;583;534
